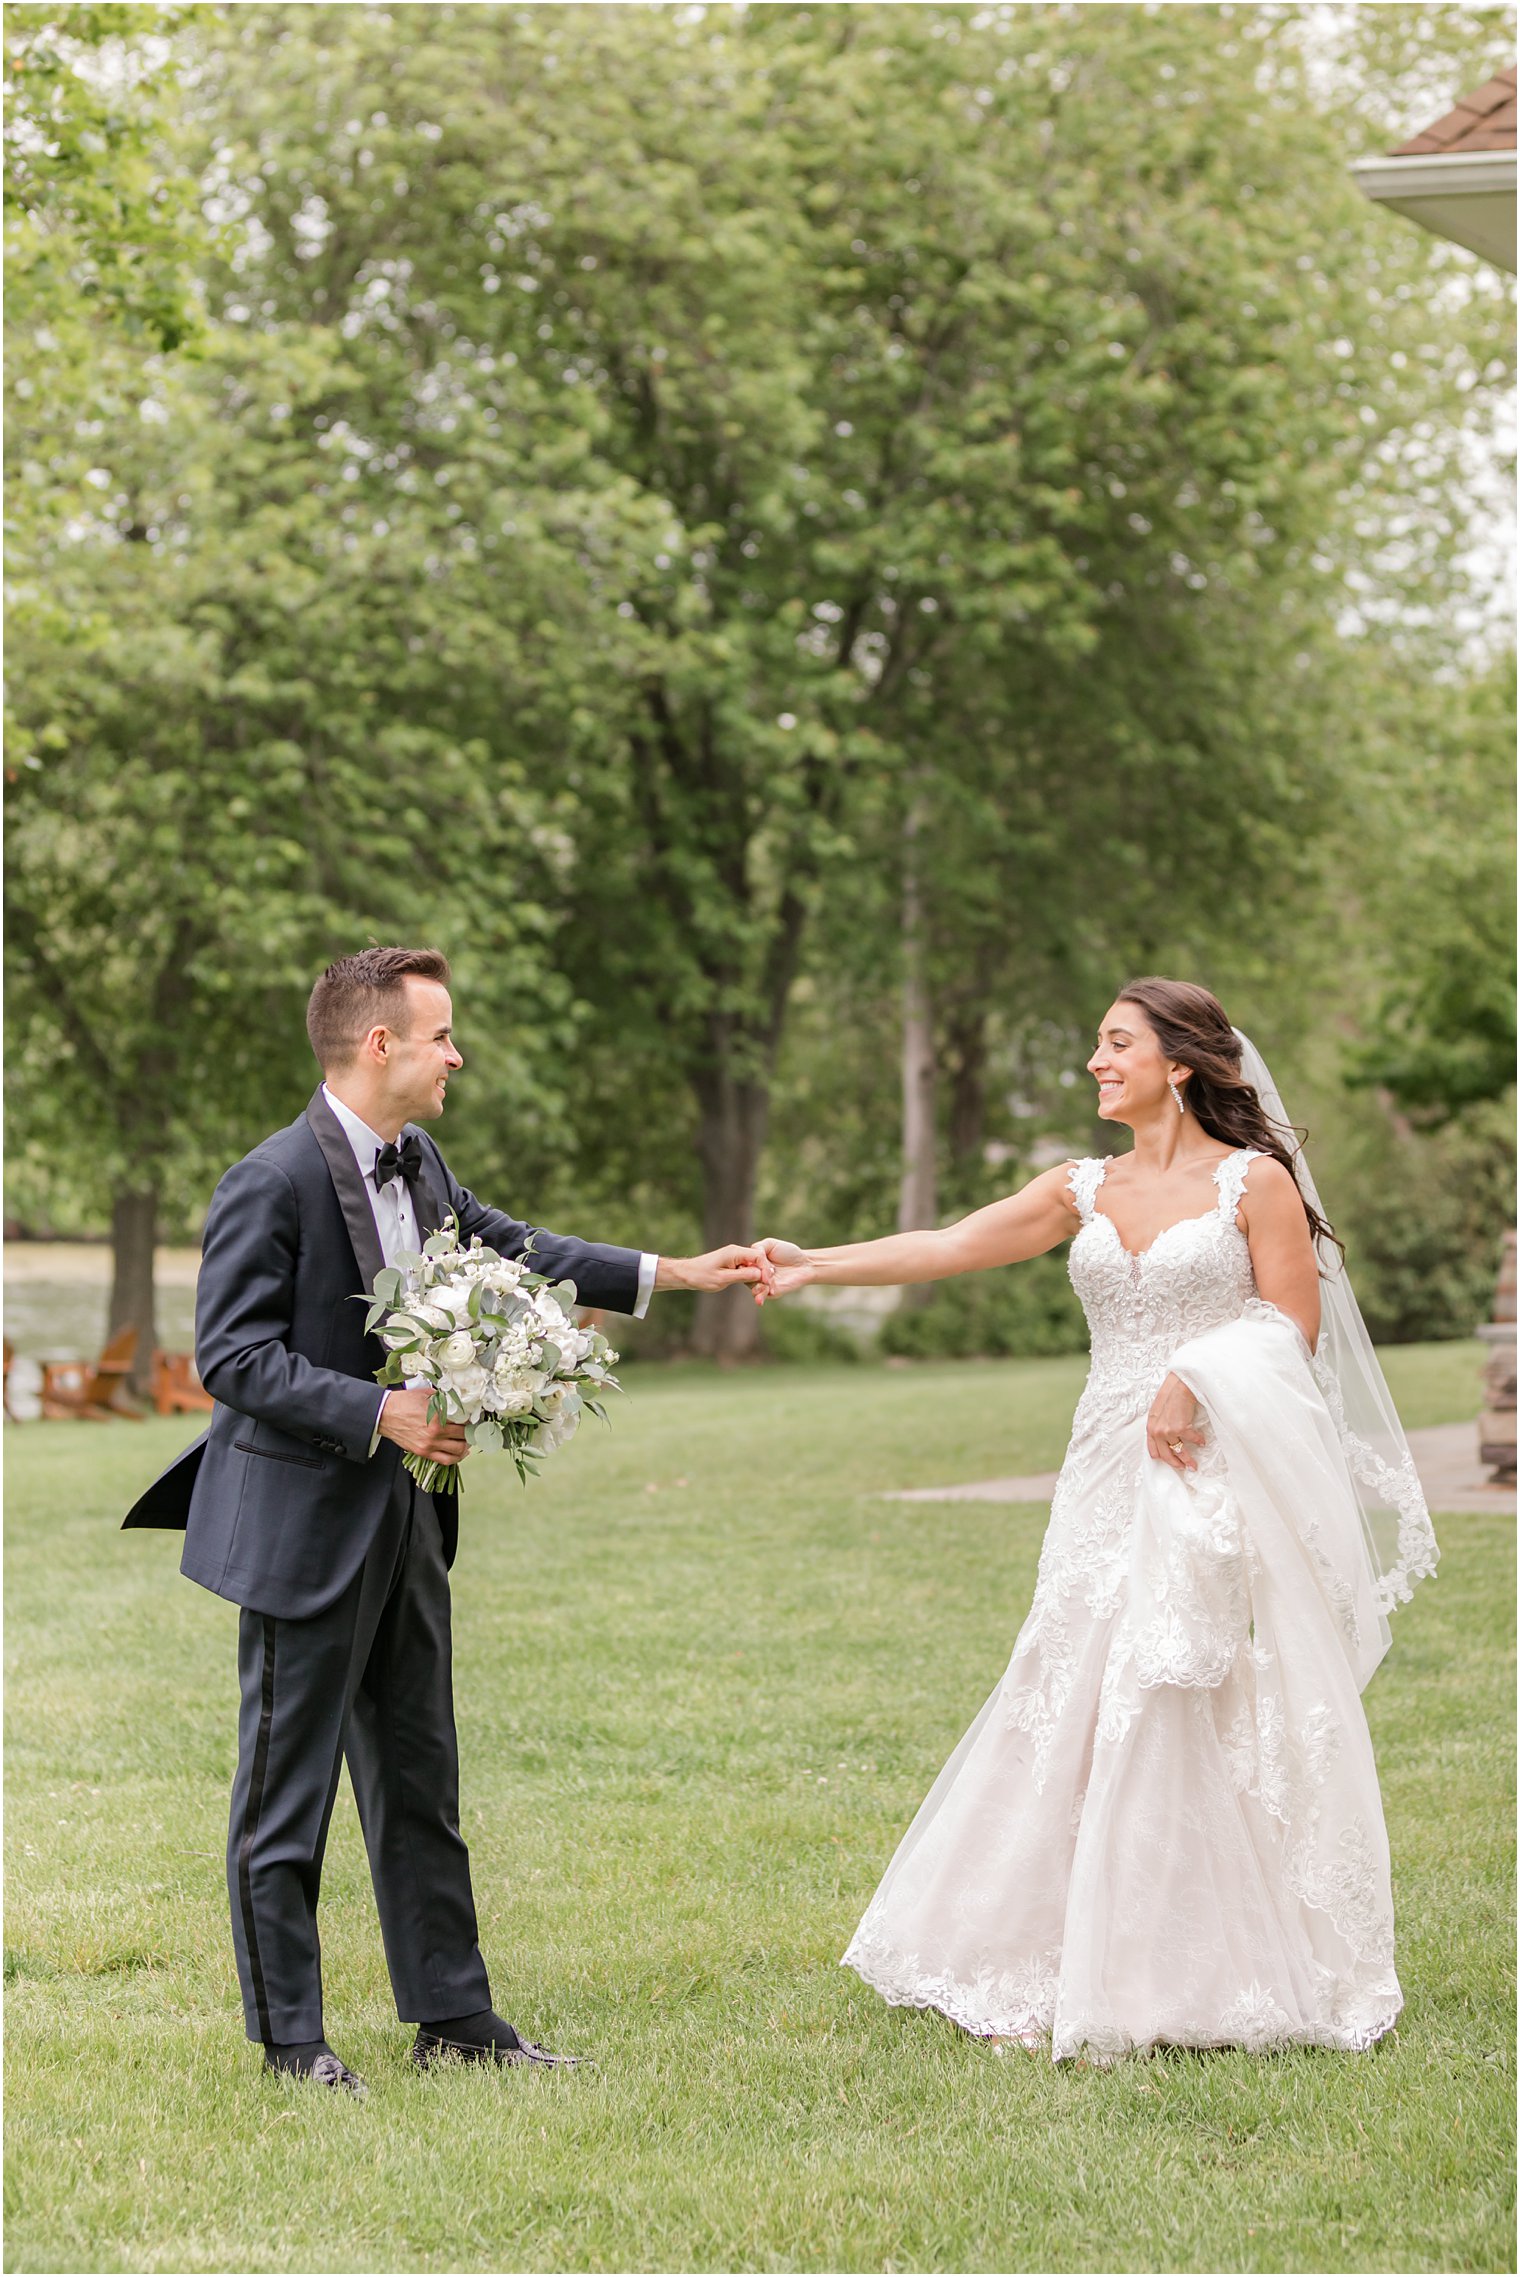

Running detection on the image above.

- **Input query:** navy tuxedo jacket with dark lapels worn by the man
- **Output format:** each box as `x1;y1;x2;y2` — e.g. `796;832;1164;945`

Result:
125;1091;639;1619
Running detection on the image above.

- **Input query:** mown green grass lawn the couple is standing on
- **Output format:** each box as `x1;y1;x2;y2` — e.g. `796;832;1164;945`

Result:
5;1346;1515;2270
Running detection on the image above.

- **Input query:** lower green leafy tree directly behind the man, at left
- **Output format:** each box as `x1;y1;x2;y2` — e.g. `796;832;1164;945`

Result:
7;316;575;1371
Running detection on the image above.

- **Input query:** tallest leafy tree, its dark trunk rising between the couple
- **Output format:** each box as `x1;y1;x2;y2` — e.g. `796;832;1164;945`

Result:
186;7;1510;1350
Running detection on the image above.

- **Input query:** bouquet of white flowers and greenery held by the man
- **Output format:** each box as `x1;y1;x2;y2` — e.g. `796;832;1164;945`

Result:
364;1218;621;1494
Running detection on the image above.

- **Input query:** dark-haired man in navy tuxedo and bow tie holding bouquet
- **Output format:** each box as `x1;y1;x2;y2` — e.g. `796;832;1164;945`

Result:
125;950;765;2095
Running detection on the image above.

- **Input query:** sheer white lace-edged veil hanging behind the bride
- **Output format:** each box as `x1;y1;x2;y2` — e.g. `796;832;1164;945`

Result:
1236;1029;1438;1614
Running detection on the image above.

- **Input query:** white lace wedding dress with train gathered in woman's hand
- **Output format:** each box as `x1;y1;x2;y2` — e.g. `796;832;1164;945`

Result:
844;1150;1410;2061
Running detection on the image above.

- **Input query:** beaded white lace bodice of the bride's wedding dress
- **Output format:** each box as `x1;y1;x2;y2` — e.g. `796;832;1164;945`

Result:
1067;1148;1258;1428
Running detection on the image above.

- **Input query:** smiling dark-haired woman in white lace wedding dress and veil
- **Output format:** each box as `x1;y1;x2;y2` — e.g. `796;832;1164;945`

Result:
755;979;1436;2061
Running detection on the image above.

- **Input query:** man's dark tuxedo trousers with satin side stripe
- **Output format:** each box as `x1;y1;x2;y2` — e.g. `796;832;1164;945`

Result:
228;1464;491;2040
